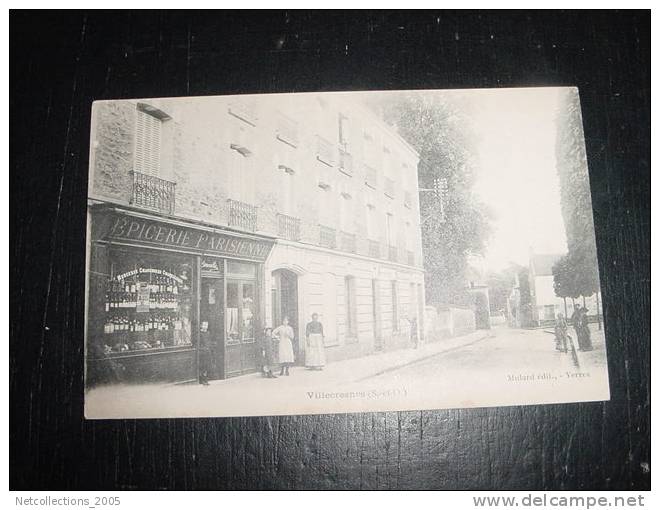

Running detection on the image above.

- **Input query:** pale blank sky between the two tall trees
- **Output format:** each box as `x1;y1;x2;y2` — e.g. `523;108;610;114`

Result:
468;88;567;271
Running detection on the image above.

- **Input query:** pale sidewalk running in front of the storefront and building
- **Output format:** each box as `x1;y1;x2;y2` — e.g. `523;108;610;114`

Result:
85;331;491;418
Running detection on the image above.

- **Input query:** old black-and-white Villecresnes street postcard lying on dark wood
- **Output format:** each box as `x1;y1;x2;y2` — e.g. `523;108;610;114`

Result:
85;88;609;419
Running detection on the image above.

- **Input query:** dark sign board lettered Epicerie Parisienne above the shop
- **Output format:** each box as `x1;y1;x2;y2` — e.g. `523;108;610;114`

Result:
107;214;273;262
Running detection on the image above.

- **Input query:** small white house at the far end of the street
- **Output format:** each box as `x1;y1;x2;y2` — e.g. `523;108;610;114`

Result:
529;253;603;323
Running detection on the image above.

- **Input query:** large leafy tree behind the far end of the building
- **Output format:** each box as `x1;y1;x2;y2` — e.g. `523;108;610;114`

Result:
380;94;490;306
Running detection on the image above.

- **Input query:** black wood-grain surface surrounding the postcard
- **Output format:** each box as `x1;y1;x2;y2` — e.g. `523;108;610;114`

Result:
9;11;651;489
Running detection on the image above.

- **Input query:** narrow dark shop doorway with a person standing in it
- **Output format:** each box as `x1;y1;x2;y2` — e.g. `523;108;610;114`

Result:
199;278;225;379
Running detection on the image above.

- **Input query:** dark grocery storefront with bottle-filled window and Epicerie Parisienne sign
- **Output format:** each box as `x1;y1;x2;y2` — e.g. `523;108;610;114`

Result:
86;206;274;386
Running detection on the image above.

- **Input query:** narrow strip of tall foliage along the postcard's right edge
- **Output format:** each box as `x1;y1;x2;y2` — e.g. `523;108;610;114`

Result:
553;88;598;297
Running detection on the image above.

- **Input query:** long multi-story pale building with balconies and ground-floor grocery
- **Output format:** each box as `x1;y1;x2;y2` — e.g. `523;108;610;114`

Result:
86;93;424;383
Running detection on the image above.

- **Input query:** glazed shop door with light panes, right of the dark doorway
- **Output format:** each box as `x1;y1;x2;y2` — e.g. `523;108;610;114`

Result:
225;279;258;377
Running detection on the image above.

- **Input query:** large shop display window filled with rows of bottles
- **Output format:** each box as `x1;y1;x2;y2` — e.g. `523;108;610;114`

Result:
98;250;193;356
